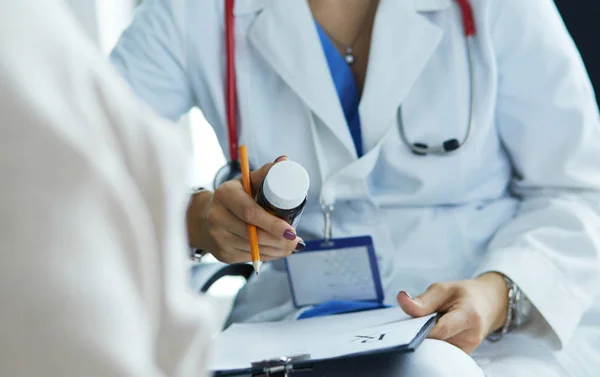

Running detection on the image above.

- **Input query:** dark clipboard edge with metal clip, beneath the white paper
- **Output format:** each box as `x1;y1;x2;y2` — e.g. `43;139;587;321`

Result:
213;308;439;377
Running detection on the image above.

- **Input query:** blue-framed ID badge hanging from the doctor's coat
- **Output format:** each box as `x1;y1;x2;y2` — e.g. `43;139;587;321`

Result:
285;236;383;308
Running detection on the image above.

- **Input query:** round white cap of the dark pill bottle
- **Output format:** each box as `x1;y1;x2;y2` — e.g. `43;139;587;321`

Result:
263;161;310;209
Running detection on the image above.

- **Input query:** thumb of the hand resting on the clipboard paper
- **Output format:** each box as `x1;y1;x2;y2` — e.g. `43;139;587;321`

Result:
398;283;454;317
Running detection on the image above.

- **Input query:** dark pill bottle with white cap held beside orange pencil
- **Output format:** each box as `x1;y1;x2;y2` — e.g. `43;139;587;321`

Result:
256;161;310;228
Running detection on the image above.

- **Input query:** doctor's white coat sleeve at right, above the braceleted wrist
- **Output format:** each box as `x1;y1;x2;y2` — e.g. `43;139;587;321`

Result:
477;0;600;347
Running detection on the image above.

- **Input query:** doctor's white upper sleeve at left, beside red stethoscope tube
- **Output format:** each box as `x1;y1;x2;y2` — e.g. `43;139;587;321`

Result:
110;0;192;121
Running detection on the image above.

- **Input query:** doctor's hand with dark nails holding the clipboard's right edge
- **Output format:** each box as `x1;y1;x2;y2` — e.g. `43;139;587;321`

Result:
398;272;508;354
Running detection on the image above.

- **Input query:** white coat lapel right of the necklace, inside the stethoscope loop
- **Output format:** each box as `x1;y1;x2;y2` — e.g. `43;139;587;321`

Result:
359;0;442;148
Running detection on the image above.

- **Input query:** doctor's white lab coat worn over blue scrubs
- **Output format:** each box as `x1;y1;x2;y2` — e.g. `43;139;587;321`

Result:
112;0;600;376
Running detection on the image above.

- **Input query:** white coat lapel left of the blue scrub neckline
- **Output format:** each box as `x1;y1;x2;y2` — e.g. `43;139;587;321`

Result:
248;0;356;158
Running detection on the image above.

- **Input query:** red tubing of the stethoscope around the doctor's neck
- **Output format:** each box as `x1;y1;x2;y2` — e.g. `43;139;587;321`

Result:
225;0;475;161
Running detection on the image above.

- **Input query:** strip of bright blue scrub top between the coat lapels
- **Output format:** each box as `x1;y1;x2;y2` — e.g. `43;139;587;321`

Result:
315;22;363;157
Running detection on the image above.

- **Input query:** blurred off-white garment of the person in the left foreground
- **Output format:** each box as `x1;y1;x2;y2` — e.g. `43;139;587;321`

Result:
0;0;217;377
